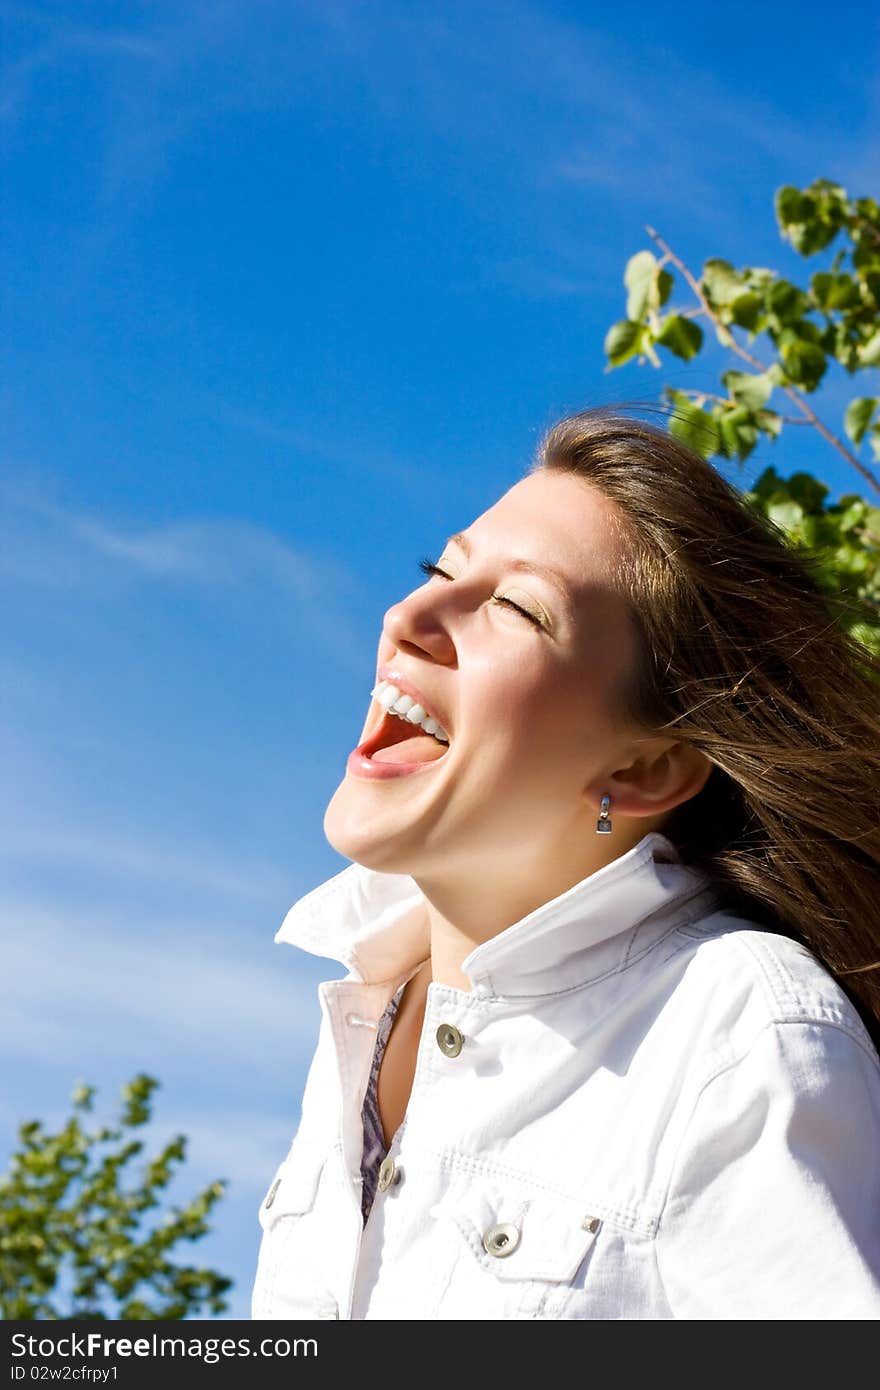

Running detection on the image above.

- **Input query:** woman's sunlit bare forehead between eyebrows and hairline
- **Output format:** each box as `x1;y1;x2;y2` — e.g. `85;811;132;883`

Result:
467;468;626;578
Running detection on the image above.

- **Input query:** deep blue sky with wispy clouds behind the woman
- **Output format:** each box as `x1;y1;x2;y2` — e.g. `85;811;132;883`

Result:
0;0;880;1316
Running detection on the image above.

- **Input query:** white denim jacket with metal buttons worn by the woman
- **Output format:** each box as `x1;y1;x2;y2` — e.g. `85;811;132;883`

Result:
252;831;880;1319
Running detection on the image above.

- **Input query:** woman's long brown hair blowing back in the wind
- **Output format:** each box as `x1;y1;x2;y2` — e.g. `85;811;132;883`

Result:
530;407;880;1049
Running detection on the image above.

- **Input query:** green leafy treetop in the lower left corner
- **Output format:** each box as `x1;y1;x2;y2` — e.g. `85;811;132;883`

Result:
0;1074;231;1319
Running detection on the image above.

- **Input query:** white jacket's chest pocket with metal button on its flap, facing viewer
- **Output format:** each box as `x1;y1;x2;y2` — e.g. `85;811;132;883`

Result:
432;1183;602;1318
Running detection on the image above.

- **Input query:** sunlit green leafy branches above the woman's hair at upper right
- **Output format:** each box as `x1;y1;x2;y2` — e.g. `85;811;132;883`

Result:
605;179;880;652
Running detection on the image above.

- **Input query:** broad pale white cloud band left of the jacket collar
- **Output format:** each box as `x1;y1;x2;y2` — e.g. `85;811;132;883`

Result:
0;892;341;1093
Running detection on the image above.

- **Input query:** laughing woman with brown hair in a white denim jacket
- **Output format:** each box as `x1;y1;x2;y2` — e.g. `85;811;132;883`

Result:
253;411;880;1319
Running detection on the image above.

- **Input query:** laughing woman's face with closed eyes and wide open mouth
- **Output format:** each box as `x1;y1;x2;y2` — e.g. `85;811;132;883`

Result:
324;470;648;880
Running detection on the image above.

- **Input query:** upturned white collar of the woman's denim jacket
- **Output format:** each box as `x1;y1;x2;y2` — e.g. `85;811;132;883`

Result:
275;831;720;995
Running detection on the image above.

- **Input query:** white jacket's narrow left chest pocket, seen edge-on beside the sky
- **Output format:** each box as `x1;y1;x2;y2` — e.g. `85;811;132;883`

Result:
252;1141;338;1319
